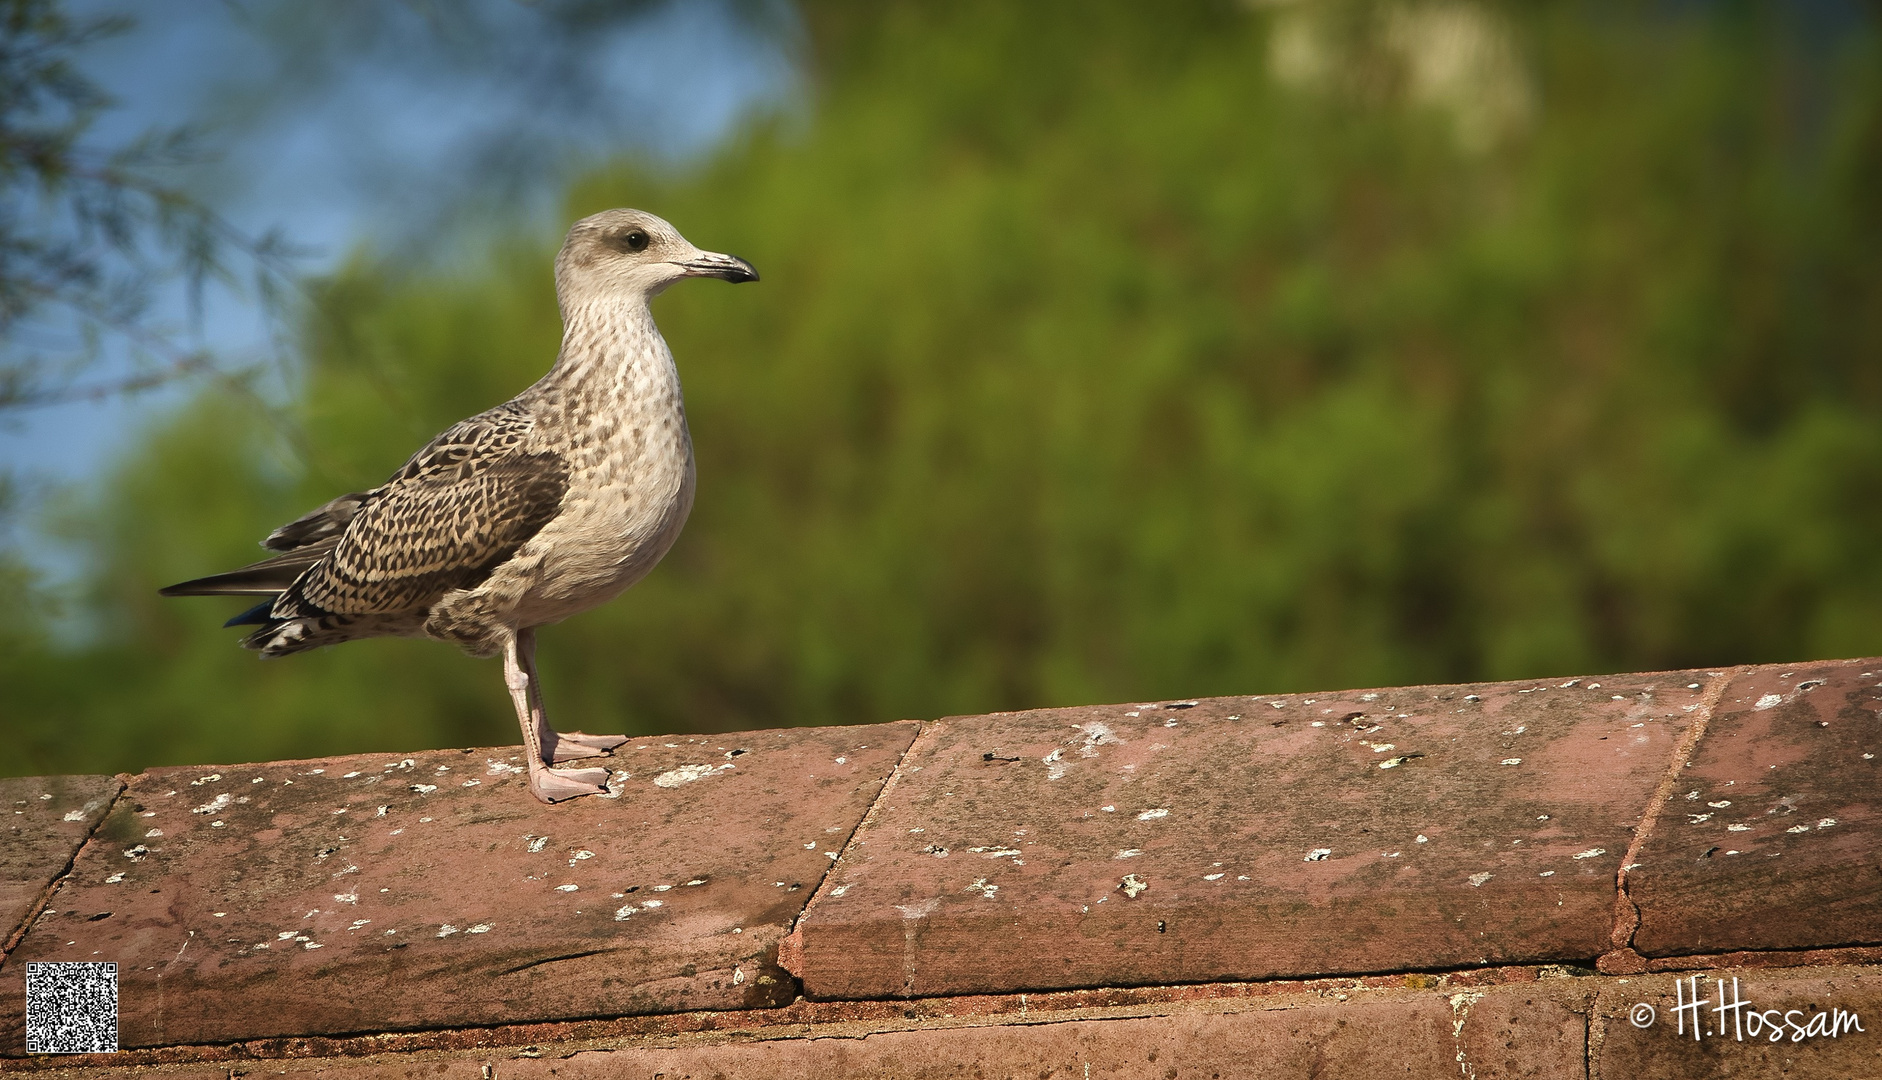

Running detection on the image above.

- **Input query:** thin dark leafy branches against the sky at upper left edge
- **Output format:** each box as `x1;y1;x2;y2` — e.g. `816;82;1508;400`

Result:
0;0;292;412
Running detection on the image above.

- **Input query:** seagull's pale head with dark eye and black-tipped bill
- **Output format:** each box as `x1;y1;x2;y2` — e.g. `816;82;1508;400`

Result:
555;209;758;307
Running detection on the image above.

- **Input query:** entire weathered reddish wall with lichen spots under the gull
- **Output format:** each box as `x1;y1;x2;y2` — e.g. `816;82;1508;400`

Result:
0;660;1882;1078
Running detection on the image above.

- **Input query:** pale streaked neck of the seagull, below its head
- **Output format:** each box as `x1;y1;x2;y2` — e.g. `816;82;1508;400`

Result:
536;297;679;425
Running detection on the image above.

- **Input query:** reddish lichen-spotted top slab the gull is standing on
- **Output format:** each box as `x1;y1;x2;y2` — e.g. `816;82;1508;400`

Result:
0;723;917;1054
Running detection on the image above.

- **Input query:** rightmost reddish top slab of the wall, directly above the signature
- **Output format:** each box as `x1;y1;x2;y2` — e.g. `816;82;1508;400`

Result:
1628;660;1882;955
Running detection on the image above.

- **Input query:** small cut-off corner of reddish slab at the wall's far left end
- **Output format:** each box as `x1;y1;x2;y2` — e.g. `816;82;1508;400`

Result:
0;777;124;945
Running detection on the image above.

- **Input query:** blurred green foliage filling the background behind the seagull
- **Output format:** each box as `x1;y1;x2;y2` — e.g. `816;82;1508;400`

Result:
0;2;1882;771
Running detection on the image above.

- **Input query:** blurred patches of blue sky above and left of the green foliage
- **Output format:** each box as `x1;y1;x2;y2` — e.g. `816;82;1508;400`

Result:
0;0;796;519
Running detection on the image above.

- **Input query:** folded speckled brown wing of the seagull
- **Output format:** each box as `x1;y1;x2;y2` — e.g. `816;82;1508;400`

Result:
271;405;568;621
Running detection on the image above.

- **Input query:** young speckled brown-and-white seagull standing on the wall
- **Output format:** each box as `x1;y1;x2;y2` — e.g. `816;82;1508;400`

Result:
160;209;758;803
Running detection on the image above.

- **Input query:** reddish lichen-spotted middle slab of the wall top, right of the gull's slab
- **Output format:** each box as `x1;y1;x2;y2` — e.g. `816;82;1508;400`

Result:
787;674;1705;999
